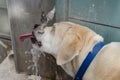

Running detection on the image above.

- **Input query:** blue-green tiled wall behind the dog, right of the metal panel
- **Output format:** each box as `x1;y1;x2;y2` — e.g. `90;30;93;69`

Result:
56;0;120;43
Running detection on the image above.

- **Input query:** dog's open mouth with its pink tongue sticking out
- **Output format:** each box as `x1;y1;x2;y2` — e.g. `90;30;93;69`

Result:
19;32;42;47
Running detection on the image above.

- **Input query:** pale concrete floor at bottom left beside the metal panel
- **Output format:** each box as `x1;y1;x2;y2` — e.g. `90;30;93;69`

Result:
0;52;41;80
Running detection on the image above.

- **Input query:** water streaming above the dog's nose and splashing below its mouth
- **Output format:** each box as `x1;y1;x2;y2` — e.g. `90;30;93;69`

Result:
25;8;55;80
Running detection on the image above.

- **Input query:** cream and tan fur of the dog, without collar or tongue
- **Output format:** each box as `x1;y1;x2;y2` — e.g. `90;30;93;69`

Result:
34;22;120;80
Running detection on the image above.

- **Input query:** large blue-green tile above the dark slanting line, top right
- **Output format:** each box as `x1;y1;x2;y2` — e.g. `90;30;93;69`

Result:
69;0;120;27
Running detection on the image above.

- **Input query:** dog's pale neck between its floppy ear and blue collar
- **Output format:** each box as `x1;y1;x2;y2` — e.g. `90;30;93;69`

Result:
61;35;103;77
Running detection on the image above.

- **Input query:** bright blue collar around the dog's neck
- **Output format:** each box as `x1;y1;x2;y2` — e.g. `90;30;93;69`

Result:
74;42;104;80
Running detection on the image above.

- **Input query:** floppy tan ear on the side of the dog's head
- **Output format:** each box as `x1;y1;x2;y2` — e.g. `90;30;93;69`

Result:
57;33;80;65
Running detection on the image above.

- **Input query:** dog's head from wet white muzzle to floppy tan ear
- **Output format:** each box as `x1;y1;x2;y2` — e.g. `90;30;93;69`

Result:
34;23;80;65
